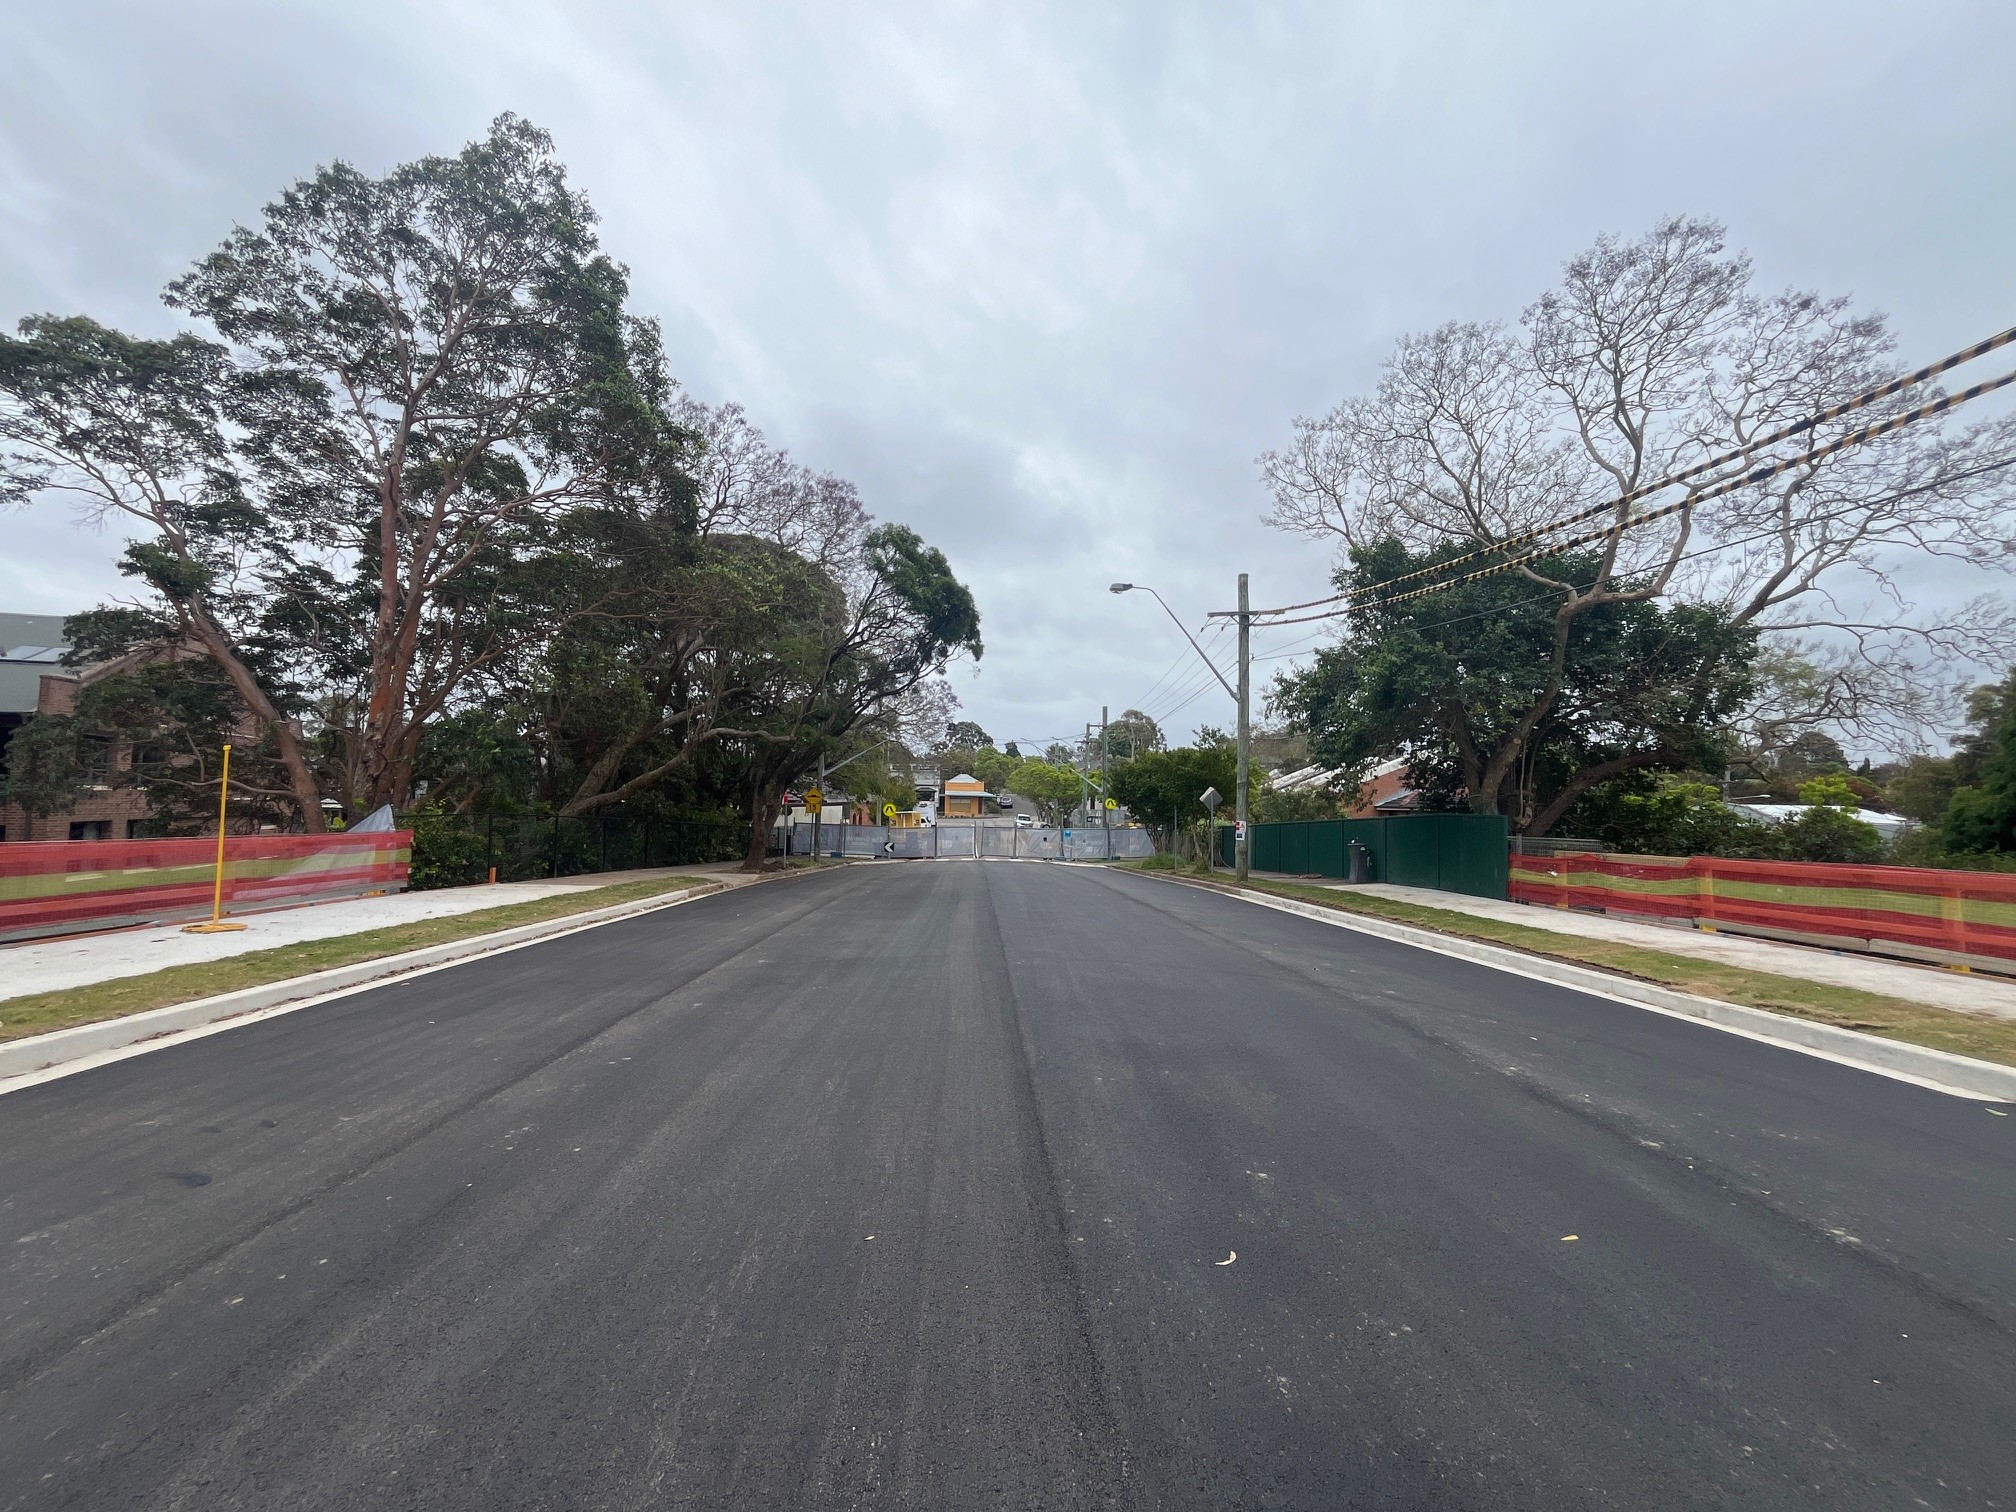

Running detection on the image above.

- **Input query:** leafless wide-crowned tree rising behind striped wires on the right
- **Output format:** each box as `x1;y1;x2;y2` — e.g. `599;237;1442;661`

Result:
1260;218;2016;810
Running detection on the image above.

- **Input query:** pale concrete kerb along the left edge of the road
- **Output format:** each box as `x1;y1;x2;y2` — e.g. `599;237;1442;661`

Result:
0;871;816;1095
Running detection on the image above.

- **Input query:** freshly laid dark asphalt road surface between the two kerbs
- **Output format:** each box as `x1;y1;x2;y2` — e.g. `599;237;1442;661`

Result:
0;863;2016;1512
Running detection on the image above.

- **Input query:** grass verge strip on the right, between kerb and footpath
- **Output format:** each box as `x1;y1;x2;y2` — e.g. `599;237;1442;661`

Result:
1145;877;2016;1066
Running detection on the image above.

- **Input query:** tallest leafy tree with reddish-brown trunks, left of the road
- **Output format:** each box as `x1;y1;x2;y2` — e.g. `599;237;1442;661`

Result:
167;115;691;810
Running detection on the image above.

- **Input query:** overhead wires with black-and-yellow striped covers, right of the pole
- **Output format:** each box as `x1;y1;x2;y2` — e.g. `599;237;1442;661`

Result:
1212;327;2016;625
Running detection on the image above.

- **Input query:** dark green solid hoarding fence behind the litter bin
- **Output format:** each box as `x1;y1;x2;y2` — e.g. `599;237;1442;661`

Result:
1218;814;1510;897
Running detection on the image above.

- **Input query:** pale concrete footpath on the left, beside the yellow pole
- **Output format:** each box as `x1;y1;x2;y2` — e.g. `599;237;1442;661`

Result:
0;861;740;1002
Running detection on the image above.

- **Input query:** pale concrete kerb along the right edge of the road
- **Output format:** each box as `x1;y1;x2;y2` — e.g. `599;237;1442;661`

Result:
1141;871;2016;1103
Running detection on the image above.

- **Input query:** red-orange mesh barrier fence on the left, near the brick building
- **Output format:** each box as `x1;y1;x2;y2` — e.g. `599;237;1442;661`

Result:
0;831;413;939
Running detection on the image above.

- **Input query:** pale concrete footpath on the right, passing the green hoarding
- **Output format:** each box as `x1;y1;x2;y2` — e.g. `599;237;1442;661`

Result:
1254;871;2016;1018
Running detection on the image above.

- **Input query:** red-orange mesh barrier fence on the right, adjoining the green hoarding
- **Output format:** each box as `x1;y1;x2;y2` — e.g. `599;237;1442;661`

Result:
1512;855;2016;972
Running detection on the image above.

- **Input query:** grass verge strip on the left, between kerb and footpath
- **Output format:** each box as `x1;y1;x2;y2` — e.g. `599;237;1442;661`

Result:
0;877;721;1040
